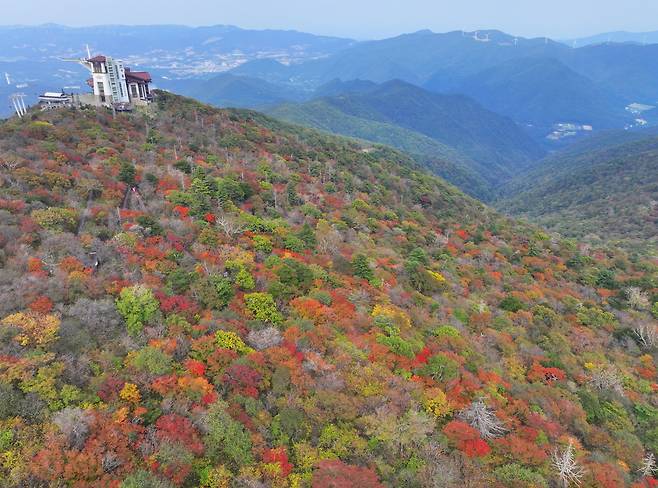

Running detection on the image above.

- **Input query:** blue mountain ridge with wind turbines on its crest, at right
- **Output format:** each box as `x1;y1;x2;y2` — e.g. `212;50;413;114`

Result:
229;30;658;137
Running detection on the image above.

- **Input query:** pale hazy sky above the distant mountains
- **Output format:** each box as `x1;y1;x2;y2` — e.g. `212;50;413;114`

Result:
5;0;658;39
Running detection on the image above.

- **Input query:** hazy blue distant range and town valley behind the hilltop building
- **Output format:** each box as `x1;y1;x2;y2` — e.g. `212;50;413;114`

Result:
0;24;355;116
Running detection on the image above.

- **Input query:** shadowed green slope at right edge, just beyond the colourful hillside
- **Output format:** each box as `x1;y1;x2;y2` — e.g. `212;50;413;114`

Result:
497;132;658;254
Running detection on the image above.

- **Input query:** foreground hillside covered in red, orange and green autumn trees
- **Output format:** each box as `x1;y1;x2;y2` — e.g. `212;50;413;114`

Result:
0;92;658;488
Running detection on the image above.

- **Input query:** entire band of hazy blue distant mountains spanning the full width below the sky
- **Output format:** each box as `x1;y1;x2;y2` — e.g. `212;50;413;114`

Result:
0;25;658;139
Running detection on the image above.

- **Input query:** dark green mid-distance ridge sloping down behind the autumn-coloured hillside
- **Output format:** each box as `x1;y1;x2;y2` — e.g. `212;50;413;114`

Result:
268;80;544;199
